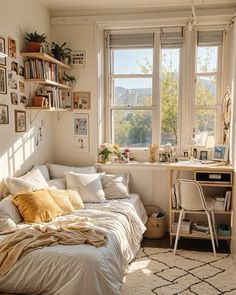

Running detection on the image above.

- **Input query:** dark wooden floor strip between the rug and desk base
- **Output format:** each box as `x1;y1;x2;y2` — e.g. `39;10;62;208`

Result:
141;234;230;253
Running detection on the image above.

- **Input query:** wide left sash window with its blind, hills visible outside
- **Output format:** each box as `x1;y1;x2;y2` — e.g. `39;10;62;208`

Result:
109;34;154;148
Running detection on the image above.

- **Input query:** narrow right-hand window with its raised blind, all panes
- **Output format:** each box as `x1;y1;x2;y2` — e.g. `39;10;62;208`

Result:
194;31;222;147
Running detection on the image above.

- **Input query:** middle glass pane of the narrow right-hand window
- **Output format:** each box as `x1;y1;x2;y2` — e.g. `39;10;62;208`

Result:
196;76;216;105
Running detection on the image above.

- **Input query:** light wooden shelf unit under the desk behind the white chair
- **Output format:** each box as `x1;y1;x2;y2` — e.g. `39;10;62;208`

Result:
169;168;233;244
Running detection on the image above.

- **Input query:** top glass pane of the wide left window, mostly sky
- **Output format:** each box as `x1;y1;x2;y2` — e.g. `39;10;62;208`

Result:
112;48;153;74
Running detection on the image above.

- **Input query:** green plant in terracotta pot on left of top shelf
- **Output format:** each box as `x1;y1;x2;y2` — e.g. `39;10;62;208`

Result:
25;31;47;52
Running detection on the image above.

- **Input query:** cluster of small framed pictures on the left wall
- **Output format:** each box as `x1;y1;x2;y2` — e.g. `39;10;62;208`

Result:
0;36;27;132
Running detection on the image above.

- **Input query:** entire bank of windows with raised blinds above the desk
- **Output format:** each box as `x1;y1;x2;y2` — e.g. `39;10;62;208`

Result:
106;27;223;153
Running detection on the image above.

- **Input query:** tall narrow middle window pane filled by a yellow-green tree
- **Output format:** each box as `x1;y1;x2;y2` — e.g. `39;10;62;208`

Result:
161;48;180;145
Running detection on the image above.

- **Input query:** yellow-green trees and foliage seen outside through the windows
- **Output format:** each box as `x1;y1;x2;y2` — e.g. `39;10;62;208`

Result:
113;48;216;147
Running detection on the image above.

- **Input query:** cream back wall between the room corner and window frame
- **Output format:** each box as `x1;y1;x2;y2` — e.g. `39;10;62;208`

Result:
51;24;98;165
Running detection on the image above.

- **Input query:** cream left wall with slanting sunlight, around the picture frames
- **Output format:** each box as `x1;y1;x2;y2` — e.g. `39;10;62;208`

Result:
0;0;53;179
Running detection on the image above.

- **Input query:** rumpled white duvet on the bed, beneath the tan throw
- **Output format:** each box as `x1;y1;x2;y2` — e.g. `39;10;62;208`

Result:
0;195;147;295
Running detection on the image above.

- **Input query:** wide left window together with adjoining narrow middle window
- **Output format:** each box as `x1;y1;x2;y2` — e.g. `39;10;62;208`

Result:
109;28;182;148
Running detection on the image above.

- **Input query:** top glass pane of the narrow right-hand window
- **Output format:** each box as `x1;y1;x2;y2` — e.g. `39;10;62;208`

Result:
197;46;218;73
